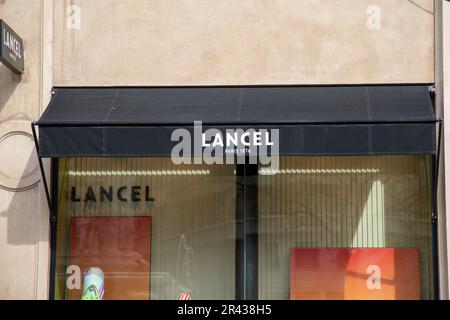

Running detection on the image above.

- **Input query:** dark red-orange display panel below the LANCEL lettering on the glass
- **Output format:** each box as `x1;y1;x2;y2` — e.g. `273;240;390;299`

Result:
67;217;151;300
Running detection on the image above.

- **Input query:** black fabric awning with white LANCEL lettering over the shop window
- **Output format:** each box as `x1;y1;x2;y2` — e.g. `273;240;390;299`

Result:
36;86;436;157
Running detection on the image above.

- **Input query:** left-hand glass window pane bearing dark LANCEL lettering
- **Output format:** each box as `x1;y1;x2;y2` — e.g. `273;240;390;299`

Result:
55;158;236;299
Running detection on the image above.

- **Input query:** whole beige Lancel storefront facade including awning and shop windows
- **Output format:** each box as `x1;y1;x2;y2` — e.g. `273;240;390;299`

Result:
0;0;450;299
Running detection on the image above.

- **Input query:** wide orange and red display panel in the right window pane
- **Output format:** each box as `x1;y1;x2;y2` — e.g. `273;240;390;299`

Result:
290;248;420;300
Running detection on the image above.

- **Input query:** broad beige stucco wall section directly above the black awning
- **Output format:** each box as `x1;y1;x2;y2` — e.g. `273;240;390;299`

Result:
54;0;434;86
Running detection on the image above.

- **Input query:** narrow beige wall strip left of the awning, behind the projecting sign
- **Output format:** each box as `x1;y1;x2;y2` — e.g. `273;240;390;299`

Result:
0;0;49;299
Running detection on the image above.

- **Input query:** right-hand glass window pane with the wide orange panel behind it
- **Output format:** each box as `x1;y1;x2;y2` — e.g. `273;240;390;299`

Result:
258;156;433;299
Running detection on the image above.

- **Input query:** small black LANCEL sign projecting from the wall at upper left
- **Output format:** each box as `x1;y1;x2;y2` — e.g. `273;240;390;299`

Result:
0;20;24;73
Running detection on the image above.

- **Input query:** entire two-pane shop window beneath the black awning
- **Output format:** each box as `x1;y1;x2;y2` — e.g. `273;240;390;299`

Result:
54;155;434;300
